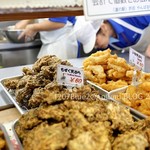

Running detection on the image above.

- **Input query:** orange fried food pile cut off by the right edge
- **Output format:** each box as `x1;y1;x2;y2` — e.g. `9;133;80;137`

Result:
111;81;150;116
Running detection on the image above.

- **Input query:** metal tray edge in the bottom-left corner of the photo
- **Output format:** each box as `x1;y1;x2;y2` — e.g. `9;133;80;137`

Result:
0;124;14;150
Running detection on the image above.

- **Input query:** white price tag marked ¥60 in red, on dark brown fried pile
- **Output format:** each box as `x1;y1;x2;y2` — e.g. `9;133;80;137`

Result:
57;65;84;86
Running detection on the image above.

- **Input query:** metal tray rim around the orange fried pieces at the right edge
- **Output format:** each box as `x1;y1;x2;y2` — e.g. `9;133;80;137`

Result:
108;86;148;119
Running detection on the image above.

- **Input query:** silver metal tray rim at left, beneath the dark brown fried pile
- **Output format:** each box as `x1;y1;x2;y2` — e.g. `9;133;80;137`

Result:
0;76;27;114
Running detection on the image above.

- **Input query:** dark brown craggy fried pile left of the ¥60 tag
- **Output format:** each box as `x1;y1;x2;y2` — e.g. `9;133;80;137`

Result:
4;55;72;109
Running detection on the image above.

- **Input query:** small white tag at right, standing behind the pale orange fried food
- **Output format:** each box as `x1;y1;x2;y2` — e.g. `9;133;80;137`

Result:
129;47;145;71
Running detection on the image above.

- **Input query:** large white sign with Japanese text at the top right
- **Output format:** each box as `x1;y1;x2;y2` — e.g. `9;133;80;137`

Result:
83;0;150;20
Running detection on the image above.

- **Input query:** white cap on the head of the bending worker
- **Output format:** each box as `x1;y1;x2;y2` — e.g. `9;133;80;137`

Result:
75;16;102;53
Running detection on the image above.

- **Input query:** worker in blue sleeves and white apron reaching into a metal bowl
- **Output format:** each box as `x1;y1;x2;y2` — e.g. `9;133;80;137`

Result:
15;16;78;59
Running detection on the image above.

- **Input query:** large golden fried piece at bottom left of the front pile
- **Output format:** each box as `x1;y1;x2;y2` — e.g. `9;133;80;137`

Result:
23;122;70;150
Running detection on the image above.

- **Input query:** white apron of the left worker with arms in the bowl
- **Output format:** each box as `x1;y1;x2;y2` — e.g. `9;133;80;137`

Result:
38;18;78;59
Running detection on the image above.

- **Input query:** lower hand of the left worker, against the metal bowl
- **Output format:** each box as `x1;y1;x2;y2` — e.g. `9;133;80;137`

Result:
18;24;37;41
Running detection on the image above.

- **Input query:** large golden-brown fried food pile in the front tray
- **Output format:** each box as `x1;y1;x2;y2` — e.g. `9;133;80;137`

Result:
14;87;150;150
